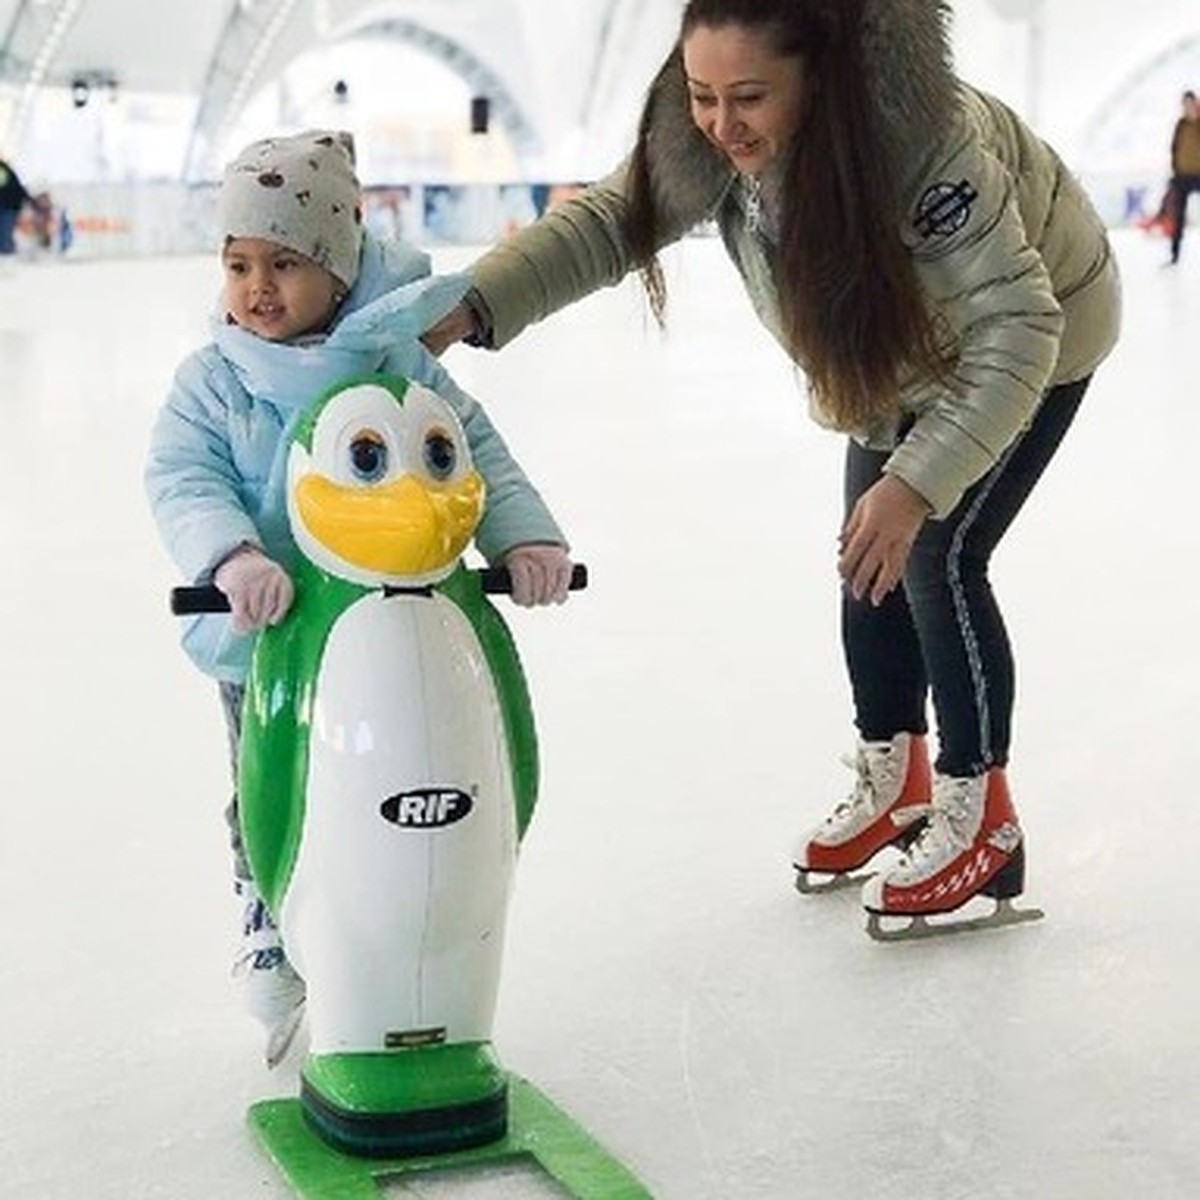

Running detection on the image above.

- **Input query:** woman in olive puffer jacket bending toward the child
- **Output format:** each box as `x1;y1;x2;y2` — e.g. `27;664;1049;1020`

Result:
427;0;1120;919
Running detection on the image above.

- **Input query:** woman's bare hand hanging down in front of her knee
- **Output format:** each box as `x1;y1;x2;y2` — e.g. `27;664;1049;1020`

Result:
838;475;930;606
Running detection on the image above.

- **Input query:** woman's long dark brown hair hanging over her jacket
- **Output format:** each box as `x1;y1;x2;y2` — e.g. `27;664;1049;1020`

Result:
628;0;947;430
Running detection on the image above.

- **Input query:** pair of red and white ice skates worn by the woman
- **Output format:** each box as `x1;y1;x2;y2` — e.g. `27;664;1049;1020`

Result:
793;733;1044;942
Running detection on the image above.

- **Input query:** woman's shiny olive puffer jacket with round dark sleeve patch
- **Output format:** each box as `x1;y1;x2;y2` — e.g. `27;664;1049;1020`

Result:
472;0;1120;516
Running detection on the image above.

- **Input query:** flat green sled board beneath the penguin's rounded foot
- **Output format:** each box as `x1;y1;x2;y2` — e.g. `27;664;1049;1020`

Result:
248;1075;653;1200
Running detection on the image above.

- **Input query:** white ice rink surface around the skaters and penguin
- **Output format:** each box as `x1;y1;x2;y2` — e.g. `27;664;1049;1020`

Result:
0;226;1200;1200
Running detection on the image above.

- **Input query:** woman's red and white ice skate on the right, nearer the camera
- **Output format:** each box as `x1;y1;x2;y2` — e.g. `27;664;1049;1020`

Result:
863;767;1044;942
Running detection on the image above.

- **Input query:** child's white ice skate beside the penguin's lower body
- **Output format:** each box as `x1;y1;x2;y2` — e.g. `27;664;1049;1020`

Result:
233;880;305;1067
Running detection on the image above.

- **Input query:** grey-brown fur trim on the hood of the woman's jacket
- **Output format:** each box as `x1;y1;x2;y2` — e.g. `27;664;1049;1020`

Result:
647;0;958;219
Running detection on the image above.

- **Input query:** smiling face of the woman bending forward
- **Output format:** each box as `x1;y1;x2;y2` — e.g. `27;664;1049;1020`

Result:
683;24;804;175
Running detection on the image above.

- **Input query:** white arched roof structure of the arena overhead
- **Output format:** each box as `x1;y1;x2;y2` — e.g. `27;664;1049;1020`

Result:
0;0;1200;178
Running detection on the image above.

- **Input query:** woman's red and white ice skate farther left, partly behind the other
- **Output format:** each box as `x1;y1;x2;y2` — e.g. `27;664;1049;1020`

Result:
793;733;931;892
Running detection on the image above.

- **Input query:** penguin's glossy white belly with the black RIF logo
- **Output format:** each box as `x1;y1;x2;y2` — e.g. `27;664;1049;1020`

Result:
281;594;516;1054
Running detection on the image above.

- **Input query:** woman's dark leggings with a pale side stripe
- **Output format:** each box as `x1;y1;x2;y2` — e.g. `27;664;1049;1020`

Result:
841;379;1090;776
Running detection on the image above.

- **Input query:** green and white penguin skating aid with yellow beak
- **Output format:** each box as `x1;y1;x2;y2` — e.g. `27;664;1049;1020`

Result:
172;376;649;1200
